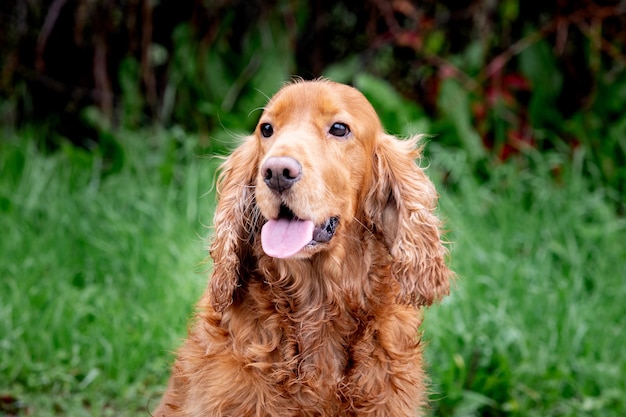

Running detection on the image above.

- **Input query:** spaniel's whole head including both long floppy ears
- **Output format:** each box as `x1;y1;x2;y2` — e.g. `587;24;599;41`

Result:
211;80;449;310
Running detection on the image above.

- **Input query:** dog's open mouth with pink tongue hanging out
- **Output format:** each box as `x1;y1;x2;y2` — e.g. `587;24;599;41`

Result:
261;205;339;258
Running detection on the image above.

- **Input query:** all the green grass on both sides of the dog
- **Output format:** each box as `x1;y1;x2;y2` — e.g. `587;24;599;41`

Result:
0;131;626;416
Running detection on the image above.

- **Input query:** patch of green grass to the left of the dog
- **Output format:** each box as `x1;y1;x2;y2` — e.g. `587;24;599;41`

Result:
0;128;215;416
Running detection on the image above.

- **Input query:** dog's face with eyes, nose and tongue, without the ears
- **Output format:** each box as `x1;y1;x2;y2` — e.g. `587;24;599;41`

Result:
255;82;382;258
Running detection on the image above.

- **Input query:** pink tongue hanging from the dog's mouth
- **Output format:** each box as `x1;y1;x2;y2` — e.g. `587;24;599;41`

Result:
261;219;315;258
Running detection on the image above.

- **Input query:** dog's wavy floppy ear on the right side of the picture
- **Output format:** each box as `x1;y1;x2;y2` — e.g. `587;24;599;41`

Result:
366;135;452;306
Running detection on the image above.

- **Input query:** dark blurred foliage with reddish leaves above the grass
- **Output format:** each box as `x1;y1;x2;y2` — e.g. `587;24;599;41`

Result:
0;0;626;207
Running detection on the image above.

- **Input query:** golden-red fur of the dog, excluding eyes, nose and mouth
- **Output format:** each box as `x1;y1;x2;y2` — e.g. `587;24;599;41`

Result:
153;80;451;417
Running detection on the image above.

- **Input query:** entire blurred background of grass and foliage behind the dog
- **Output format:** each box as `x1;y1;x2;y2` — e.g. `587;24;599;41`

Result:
0;0;626;416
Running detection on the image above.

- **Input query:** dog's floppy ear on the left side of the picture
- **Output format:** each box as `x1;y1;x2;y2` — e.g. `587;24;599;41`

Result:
209;136;259;311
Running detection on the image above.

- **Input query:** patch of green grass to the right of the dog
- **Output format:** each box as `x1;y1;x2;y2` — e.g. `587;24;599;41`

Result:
426;145;626;417
